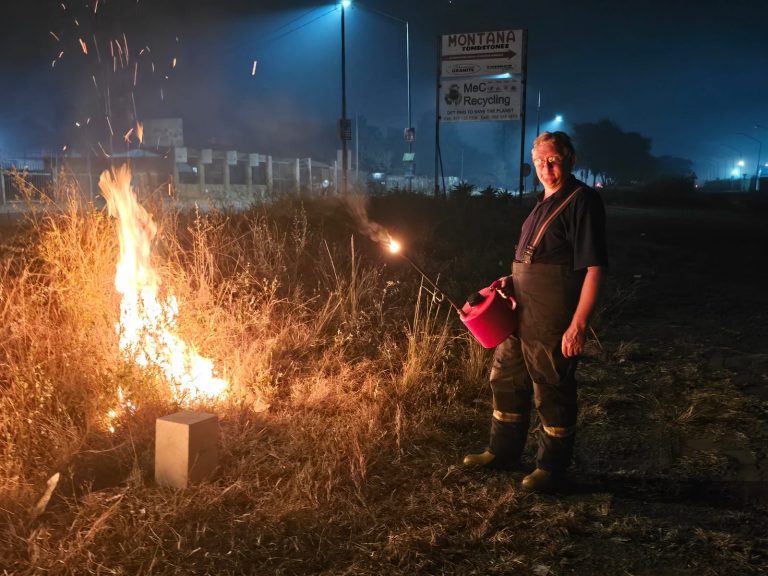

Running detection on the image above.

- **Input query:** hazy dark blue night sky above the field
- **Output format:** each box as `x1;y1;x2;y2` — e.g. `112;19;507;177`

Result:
0;0;768;184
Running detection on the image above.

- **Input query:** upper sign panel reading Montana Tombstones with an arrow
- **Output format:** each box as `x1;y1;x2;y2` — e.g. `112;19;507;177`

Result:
440;30;523;78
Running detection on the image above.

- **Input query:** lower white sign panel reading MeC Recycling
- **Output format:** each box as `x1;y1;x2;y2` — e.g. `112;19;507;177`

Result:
440;78;522;122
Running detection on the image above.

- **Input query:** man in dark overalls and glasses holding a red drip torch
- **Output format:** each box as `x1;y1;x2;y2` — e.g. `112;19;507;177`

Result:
464;132;608;492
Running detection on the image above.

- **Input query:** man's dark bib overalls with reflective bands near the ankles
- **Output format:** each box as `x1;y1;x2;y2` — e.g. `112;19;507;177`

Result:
489;262;585;472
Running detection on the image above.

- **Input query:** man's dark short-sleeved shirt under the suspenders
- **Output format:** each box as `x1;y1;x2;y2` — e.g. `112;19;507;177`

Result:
515;175;608;270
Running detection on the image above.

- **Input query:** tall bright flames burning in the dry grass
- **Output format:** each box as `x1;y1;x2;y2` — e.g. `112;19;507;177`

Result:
99;165;227;402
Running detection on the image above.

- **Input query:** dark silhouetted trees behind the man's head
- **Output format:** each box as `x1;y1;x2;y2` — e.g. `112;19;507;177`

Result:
572;119;696;185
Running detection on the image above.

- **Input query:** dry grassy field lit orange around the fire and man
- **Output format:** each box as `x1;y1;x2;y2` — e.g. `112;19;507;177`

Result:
0;181;768;576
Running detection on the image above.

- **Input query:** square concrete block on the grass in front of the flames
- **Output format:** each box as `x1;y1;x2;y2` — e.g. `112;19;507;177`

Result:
155;411;219;488
